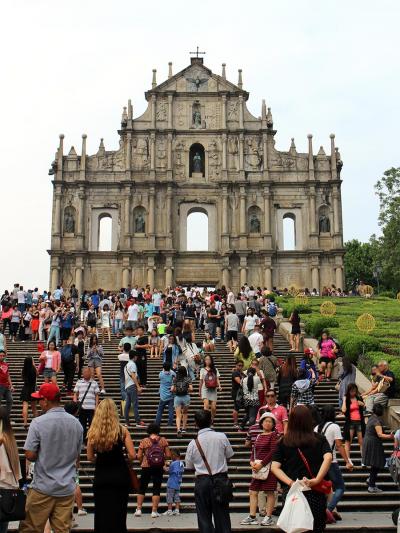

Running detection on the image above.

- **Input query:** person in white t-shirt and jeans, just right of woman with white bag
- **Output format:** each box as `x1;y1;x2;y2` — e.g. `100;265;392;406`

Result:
314;405;353;524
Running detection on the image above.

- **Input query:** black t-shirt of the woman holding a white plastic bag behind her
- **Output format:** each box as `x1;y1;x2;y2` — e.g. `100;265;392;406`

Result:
272;433;332;481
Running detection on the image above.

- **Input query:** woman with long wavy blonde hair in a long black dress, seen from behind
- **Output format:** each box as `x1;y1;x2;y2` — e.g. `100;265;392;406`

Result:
87;398;136;533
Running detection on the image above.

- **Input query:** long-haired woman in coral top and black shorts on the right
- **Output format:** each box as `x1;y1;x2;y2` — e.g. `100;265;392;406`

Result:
342;383;365;459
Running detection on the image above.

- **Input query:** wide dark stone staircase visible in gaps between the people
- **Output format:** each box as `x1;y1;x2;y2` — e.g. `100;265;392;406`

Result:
4;333;400;533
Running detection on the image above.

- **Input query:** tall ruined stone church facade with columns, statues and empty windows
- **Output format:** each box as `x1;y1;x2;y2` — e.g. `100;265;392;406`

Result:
49;57;344;290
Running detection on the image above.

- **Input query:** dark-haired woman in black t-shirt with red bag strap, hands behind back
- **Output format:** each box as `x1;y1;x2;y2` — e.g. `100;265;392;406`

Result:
271;405;332;533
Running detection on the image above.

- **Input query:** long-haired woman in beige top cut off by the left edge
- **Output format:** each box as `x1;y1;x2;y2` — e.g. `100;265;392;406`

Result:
0;407;22;533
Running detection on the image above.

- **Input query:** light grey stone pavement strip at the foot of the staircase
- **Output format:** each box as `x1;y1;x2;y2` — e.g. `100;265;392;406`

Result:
9;512;396;533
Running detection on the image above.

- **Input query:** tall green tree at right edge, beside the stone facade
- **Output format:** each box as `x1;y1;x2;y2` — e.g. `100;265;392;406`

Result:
375;167;400;288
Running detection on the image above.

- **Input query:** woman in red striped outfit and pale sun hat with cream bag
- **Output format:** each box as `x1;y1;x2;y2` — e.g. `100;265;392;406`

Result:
241;413;278;526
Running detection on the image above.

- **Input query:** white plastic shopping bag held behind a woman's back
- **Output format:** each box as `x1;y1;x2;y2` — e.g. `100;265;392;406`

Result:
277;480;314;533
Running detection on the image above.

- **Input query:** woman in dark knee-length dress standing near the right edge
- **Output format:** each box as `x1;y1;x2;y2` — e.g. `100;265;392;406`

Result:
362;404;394;494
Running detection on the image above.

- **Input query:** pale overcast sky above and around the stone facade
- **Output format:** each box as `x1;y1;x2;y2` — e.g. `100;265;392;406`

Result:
0;0;400;290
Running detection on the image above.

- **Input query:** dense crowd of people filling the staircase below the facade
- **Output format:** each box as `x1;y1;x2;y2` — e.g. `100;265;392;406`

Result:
0;284;400;533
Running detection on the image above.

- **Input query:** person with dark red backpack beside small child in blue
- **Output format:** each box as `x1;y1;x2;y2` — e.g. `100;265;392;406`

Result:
133;424;171;518
